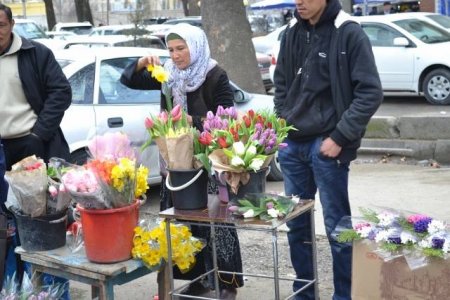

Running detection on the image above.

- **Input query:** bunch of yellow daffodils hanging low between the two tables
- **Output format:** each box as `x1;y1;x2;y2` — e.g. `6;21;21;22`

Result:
131;221;204;272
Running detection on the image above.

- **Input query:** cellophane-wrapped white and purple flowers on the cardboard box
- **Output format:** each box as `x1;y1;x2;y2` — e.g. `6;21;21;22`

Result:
332;208;450;270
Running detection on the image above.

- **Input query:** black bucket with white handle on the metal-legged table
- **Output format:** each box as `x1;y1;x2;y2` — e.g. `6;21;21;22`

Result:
166;169;208;210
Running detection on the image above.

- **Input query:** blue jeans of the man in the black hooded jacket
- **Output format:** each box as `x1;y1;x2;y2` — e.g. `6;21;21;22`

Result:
278;138;352;300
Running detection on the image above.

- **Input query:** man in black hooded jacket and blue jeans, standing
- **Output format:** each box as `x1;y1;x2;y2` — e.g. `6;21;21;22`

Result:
274;0;383;300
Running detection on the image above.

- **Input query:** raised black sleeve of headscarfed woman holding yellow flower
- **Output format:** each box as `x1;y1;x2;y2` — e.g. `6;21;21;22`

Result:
120;59;161;90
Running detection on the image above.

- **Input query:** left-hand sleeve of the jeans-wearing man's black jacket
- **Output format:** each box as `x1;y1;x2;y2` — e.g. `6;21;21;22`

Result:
273;28;288;117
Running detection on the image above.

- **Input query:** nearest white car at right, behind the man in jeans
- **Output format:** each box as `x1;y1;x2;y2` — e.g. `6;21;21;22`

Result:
270;13;450;105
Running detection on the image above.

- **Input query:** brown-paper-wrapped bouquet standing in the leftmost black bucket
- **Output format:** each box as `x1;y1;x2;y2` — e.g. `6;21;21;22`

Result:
5;155;47;217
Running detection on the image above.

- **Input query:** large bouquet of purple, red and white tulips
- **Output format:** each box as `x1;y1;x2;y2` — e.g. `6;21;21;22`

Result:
199;106;295;193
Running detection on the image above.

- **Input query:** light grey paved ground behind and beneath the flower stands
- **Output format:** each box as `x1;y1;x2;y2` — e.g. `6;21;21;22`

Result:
67;157;450;300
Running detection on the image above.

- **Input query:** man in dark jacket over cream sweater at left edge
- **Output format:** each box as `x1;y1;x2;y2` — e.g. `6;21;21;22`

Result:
0;4;72;298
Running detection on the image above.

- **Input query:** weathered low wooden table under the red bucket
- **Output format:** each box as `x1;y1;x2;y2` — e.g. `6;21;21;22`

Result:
15;246;159;300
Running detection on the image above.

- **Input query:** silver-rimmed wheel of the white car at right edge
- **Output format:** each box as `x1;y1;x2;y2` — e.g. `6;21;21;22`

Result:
422;69;450;105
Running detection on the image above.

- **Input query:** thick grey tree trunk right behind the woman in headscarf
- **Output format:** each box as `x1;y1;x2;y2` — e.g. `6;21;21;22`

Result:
201;0;265;94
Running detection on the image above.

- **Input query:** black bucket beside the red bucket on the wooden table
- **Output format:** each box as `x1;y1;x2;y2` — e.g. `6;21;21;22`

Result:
15;210;67;251
